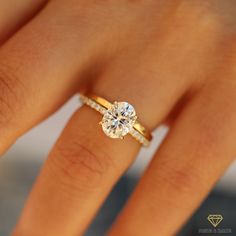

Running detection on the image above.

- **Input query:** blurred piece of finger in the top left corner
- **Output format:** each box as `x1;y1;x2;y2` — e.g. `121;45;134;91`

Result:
0;0;46;44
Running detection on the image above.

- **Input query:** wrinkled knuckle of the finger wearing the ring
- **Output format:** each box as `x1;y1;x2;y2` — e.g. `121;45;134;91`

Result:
48;140;111;189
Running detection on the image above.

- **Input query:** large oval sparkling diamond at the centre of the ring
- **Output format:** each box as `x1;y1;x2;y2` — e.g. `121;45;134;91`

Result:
101;102;137;138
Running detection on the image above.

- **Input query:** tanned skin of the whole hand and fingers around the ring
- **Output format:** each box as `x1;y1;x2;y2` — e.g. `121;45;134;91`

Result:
0;0;236;236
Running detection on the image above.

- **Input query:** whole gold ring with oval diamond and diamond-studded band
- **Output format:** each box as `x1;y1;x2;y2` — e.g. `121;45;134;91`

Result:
80;94;152;146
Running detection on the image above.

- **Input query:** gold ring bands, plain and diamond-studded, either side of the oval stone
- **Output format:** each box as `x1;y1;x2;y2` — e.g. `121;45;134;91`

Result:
80;94;152;146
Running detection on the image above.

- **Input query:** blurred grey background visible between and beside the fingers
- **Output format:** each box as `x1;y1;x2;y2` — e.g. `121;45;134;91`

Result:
0;97;236;236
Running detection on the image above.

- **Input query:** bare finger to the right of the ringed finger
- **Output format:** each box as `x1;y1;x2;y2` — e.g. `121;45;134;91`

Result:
110;77;236;236
